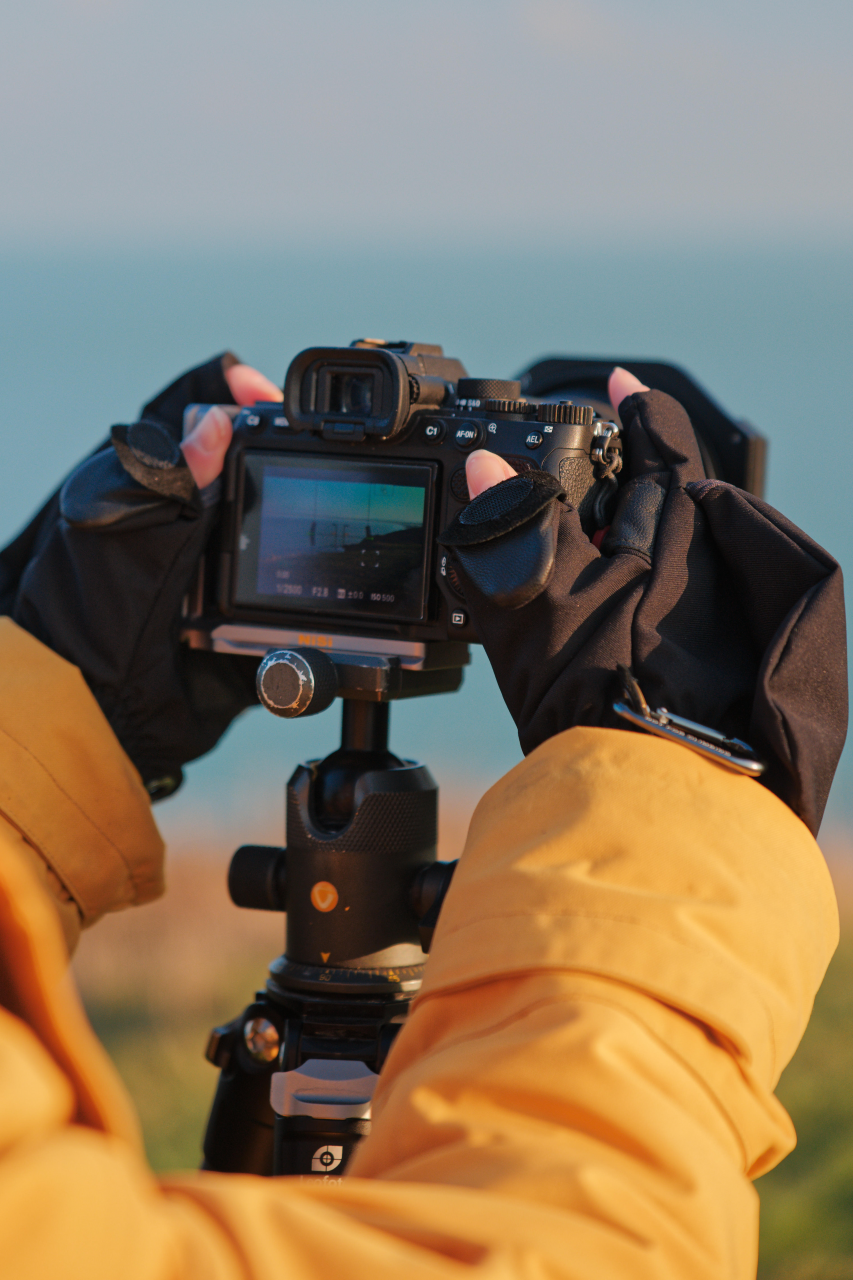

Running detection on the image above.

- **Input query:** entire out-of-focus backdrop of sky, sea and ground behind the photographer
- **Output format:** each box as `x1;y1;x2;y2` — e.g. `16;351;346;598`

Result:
0;0;853;1280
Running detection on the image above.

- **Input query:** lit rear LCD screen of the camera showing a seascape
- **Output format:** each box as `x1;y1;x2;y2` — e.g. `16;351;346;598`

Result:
236;451;433;622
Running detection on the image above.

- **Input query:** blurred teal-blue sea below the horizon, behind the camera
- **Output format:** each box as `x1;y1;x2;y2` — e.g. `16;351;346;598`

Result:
0;243;853;856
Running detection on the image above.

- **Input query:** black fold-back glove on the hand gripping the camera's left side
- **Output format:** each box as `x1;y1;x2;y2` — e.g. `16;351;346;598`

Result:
0;353;257;799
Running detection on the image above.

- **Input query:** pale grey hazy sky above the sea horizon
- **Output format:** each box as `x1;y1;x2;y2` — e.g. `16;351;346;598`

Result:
0;0;853;248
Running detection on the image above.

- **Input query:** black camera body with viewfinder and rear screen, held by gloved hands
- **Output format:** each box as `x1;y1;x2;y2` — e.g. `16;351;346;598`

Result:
184;340;619;668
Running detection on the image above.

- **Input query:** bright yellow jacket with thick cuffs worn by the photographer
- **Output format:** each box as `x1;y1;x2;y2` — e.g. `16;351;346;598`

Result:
0;620;838;1280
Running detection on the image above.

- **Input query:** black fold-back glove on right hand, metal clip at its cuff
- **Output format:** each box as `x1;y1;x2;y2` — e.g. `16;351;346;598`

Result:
441;392;847;833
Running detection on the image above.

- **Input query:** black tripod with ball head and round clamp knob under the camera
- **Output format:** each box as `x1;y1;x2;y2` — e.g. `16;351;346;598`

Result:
202;644;467;1176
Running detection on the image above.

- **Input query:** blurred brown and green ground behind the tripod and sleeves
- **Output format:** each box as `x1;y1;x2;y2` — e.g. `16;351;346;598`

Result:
74;814;853;1280
